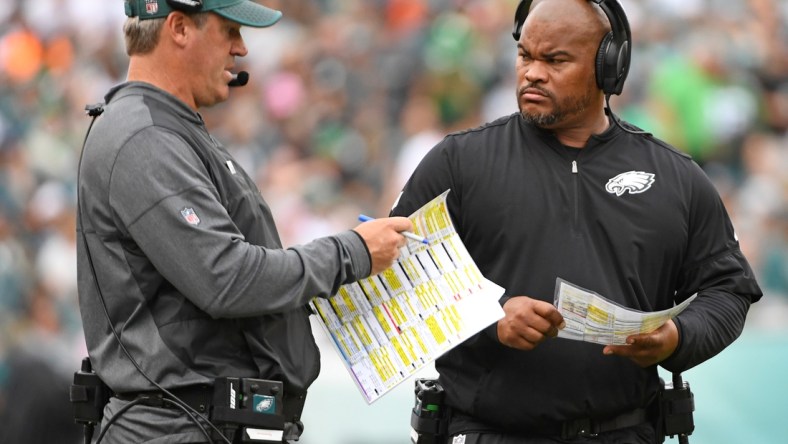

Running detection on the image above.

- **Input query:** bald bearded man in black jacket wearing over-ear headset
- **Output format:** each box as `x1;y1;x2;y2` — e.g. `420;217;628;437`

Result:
392;0;761;444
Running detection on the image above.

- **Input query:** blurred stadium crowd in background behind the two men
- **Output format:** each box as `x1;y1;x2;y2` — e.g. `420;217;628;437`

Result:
0;0;788;442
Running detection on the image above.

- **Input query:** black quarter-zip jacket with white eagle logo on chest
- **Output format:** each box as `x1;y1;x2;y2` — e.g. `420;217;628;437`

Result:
392;113;761;432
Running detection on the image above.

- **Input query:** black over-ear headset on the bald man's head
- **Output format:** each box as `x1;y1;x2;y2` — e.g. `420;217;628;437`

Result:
516;0;632;96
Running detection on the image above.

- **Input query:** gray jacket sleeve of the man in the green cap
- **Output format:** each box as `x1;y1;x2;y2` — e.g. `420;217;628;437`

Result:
109;129;371;318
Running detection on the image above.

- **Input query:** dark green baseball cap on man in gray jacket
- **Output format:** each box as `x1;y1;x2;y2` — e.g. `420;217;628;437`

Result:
125;0;282;28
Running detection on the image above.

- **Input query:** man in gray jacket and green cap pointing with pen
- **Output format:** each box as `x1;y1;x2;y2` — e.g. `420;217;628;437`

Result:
78;0;411;443
